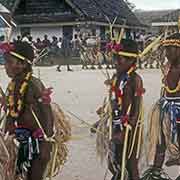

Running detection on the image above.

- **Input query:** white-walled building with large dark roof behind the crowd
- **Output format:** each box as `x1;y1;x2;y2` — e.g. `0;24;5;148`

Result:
0;0;144;39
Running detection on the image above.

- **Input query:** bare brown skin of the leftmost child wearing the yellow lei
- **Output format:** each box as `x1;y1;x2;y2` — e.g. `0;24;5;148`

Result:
5;55;53;180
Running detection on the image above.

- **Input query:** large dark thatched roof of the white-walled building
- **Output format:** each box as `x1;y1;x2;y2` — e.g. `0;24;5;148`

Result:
0;0;142;27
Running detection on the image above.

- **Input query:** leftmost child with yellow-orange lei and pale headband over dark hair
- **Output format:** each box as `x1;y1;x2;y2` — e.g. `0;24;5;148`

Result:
4;42;54;180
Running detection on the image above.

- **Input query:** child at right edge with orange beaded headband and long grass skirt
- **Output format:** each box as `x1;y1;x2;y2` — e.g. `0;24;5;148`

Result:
143;33;180;179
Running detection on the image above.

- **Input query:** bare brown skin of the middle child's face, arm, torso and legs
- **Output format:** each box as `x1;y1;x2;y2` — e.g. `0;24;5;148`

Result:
109;56;143;180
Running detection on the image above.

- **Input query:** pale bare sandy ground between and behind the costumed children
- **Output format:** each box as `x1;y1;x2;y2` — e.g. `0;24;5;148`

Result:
0;66;179;180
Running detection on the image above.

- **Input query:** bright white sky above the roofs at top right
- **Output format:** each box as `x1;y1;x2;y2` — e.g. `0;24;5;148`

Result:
129;0;180;10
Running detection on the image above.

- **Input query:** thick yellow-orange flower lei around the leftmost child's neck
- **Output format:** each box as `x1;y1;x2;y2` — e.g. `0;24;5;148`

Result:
7;72;32;118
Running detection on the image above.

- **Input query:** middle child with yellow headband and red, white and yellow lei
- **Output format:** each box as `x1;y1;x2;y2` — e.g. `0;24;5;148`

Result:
97;39;144;180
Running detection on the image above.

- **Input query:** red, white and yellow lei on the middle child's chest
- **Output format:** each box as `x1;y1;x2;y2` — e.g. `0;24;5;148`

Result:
111;65;136;109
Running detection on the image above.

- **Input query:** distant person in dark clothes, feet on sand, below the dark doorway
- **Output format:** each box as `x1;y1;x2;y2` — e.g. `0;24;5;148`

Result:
57;36;73;72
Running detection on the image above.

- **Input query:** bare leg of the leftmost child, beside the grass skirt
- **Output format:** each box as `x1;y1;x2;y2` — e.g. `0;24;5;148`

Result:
27;142;51;180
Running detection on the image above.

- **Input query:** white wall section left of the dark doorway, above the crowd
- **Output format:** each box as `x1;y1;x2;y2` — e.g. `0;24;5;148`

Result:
31;27;63;40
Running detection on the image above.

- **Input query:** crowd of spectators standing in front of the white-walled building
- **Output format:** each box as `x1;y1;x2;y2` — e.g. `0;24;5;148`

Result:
9;32;151;71
